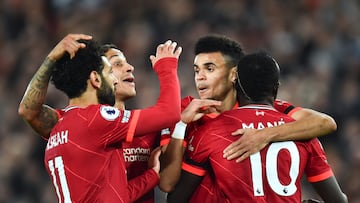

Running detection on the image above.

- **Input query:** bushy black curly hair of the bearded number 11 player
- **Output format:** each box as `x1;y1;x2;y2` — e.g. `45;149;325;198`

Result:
51;40;104;99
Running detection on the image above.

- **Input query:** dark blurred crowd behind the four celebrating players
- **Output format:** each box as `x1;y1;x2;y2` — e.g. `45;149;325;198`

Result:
0;0;360;203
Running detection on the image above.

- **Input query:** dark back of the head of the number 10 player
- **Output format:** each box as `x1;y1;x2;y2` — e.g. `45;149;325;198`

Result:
235;51;280;102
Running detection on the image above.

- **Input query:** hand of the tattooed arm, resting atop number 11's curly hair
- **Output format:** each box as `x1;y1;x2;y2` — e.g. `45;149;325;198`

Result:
48;34;92;61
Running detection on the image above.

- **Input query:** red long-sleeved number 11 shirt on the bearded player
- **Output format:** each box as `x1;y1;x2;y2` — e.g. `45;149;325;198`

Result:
44;58;180;202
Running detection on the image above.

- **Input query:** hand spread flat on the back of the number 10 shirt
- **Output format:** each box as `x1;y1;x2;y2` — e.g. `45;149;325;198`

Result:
223;129;269;162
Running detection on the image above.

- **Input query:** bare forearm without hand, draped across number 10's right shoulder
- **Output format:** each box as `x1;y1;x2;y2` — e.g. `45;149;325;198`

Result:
263;113;336;141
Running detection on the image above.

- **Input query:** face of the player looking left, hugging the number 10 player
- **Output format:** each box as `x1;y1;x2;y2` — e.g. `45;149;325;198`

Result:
194;52;235;101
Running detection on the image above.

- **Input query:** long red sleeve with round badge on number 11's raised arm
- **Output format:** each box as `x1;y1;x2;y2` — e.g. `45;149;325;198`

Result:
95;57;180;144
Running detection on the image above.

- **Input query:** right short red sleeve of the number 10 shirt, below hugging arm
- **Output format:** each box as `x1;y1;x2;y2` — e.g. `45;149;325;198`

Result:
306;139;334;182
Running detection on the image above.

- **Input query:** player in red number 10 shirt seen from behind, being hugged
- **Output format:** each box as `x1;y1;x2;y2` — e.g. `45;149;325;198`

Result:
168;52;347;203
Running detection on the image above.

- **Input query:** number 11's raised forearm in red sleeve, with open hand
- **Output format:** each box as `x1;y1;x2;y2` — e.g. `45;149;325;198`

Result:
135;40;182;135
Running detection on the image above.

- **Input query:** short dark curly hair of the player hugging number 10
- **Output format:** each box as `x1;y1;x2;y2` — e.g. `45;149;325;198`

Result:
194;34;244;68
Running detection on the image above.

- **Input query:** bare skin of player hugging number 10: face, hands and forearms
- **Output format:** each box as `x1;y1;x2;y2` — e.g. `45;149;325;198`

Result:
159;52;336;192
